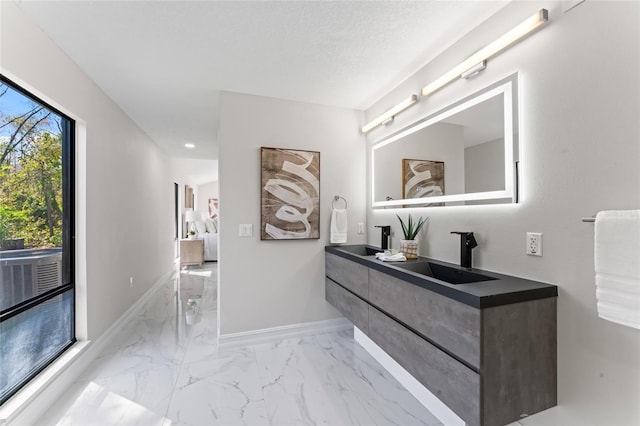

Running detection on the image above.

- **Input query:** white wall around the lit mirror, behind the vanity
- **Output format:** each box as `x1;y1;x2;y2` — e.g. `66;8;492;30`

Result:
367;0;640;425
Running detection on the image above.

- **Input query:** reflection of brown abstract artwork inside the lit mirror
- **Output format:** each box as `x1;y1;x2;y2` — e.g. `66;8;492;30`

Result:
402;158;445;207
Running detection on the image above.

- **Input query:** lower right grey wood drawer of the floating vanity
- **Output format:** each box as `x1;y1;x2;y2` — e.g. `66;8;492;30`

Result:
368;306;480;425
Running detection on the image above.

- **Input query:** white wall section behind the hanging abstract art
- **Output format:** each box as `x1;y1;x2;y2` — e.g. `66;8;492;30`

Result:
219;93;365;335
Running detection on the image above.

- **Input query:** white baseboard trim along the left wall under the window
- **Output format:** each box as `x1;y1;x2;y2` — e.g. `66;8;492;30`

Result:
0;270;174;426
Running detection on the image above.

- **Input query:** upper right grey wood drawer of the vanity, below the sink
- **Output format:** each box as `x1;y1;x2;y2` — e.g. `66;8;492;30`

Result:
368;269;481;368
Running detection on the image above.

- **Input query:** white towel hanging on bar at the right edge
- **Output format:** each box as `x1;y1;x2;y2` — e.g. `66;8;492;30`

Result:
594;210;640;329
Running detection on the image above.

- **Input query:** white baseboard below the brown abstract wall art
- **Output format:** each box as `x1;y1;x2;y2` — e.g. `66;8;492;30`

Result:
218;318;353;348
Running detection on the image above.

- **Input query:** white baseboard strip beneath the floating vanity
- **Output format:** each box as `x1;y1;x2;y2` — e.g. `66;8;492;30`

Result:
353;326;465;426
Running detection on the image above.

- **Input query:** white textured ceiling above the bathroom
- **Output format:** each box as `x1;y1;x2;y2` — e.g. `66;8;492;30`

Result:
19;1;508;159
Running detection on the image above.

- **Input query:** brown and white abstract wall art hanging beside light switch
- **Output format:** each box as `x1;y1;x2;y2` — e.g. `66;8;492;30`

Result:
260;147;320;240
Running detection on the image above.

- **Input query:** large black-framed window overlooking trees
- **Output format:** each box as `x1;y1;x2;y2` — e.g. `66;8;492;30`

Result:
0;75;75;404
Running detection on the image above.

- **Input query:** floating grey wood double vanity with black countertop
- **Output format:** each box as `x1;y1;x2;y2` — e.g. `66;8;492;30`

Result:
325;246;558;426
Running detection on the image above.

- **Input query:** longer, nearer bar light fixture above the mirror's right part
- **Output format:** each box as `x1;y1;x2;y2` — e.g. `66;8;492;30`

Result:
420;9;549;97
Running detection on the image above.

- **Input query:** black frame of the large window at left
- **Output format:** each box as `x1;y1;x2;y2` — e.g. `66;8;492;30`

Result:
0;74;77;406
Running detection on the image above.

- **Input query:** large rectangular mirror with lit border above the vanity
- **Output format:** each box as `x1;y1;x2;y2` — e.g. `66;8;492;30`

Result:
371;74;518;207
